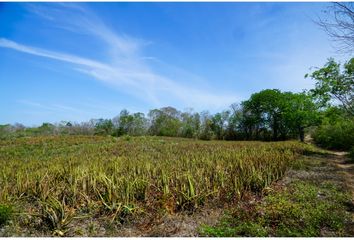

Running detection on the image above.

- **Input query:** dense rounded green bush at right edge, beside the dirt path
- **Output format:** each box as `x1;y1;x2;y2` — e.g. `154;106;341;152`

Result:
313;119;354;150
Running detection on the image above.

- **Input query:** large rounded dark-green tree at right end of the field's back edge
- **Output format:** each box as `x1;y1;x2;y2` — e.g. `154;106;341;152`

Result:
239;89;319;141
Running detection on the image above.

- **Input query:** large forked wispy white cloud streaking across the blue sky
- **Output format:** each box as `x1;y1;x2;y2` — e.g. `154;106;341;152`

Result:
0;3;240;109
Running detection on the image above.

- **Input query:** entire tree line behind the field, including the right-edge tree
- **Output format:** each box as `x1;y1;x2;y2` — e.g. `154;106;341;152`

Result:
0;58;354;148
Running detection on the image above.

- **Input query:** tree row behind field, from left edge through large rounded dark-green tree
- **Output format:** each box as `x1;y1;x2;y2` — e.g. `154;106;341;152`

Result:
0;89;319;141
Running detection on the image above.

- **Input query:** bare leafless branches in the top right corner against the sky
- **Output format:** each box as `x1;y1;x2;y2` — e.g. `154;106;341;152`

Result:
316;2;354;54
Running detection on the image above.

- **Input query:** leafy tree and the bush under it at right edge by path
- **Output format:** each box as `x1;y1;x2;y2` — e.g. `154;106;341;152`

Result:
308;58;354;150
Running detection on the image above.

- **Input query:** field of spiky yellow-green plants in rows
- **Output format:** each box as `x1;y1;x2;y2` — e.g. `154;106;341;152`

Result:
0;136;350;236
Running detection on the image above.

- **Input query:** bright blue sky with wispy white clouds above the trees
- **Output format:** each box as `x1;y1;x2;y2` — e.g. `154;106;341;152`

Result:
0;2;341;126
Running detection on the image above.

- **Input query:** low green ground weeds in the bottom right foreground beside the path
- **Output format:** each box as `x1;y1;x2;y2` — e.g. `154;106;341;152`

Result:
200;163;350;237
